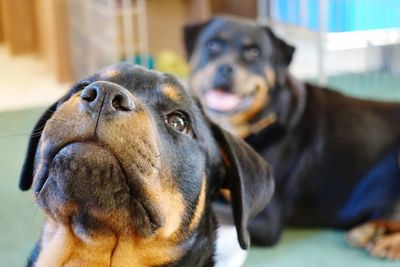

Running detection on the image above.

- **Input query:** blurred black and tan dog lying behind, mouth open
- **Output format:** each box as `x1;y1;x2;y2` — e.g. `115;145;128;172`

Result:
184;17;400;258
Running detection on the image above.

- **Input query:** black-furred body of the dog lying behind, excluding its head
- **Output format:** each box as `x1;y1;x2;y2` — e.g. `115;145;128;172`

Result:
246;84;400;245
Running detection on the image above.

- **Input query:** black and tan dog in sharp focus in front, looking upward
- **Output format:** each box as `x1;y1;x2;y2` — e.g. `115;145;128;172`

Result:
20;63;273;267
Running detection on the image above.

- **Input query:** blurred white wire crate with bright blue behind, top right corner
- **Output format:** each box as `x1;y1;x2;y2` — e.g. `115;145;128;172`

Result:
258;0;400;100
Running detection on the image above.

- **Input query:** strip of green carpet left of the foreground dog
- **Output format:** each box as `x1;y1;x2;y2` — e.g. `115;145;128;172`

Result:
0;109;43;267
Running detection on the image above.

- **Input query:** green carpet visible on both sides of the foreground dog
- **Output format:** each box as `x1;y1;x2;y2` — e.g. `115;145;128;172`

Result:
0;103;400;267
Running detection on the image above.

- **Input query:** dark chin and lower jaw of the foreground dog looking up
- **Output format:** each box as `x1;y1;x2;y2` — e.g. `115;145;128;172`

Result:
37;143;161;237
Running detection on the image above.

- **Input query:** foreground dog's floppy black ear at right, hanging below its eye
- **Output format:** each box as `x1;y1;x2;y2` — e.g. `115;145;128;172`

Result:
212;123;274;249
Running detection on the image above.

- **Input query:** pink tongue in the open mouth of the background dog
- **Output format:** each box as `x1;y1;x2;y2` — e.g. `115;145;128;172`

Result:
205;90;241;111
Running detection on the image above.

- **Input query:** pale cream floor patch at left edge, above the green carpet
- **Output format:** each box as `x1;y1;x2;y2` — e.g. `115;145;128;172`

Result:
0;46;69;111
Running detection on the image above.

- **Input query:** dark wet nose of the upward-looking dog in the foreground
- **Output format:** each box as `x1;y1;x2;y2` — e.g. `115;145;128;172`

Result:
81;81;135;114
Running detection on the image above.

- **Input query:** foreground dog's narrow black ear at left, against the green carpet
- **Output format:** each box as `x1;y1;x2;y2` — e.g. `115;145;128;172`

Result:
19;102;58;191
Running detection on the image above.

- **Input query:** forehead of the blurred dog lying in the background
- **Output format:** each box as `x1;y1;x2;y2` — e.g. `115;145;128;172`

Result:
200;17;272;46
